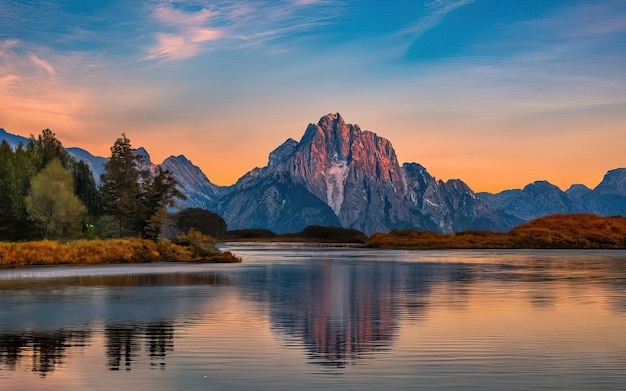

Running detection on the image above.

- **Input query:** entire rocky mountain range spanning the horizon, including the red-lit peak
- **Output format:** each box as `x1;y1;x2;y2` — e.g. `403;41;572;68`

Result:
0;113;626;234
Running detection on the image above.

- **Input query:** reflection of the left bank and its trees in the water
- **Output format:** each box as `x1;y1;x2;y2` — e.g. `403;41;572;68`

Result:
0;272;230;377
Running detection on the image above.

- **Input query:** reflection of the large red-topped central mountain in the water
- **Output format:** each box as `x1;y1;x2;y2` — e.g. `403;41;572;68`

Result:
240;259;488;368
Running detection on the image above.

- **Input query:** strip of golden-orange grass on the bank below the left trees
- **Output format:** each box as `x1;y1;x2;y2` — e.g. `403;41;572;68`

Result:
0;239;241;266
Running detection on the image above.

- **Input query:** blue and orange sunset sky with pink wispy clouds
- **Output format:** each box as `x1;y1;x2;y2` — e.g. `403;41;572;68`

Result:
0;0;626;192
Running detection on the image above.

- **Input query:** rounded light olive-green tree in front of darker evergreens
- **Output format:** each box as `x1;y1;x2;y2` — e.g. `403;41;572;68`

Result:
26;159;87;239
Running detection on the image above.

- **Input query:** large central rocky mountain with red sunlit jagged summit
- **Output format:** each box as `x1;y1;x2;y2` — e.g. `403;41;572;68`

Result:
218;114;519;234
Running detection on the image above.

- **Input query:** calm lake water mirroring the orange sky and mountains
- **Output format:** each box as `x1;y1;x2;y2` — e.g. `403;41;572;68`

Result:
0;244;626;391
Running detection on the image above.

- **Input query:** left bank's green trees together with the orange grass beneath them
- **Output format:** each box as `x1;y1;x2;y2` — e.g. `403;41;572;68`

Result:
0;129;241;265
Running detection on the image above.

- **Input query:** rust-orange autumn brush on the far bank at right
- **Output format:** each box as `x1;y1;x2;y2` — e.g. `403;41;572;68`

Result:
366;214;626;250
